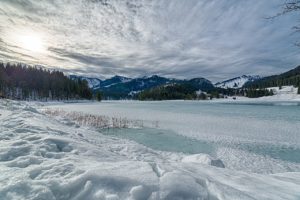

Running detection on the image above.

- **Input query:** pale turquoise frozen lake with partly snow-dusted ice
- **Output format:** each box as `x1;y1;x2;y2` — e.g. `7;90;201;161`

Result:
47;101;300;173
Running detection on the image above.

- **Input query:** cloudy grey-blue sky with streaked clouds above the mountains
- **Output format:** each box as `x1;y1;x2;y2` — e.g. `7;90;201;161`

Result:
0;0;300;82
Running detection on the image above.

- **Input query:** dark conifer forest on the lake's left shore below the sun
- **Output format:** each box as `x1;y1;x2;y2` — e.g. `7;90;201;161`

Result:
0;63;93;100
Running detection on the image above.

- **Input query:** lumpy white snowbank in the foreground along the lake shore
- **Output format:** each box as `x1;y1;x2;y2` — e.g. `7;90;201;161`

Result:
0;100;300;200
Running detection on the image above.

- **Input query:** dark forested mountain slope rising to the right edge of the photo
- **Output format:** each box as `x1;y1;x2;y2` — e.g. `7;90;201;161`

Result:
245;66;300;88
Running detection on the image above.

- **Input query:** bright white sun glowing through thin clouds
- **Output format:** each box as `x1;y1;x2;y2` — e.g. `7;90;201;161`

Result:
18;33;44;53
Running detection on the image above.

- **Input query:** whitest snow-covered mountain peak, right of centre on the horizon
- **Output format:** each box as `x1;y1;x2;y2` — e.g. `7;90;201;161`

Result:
215;75;261;89
